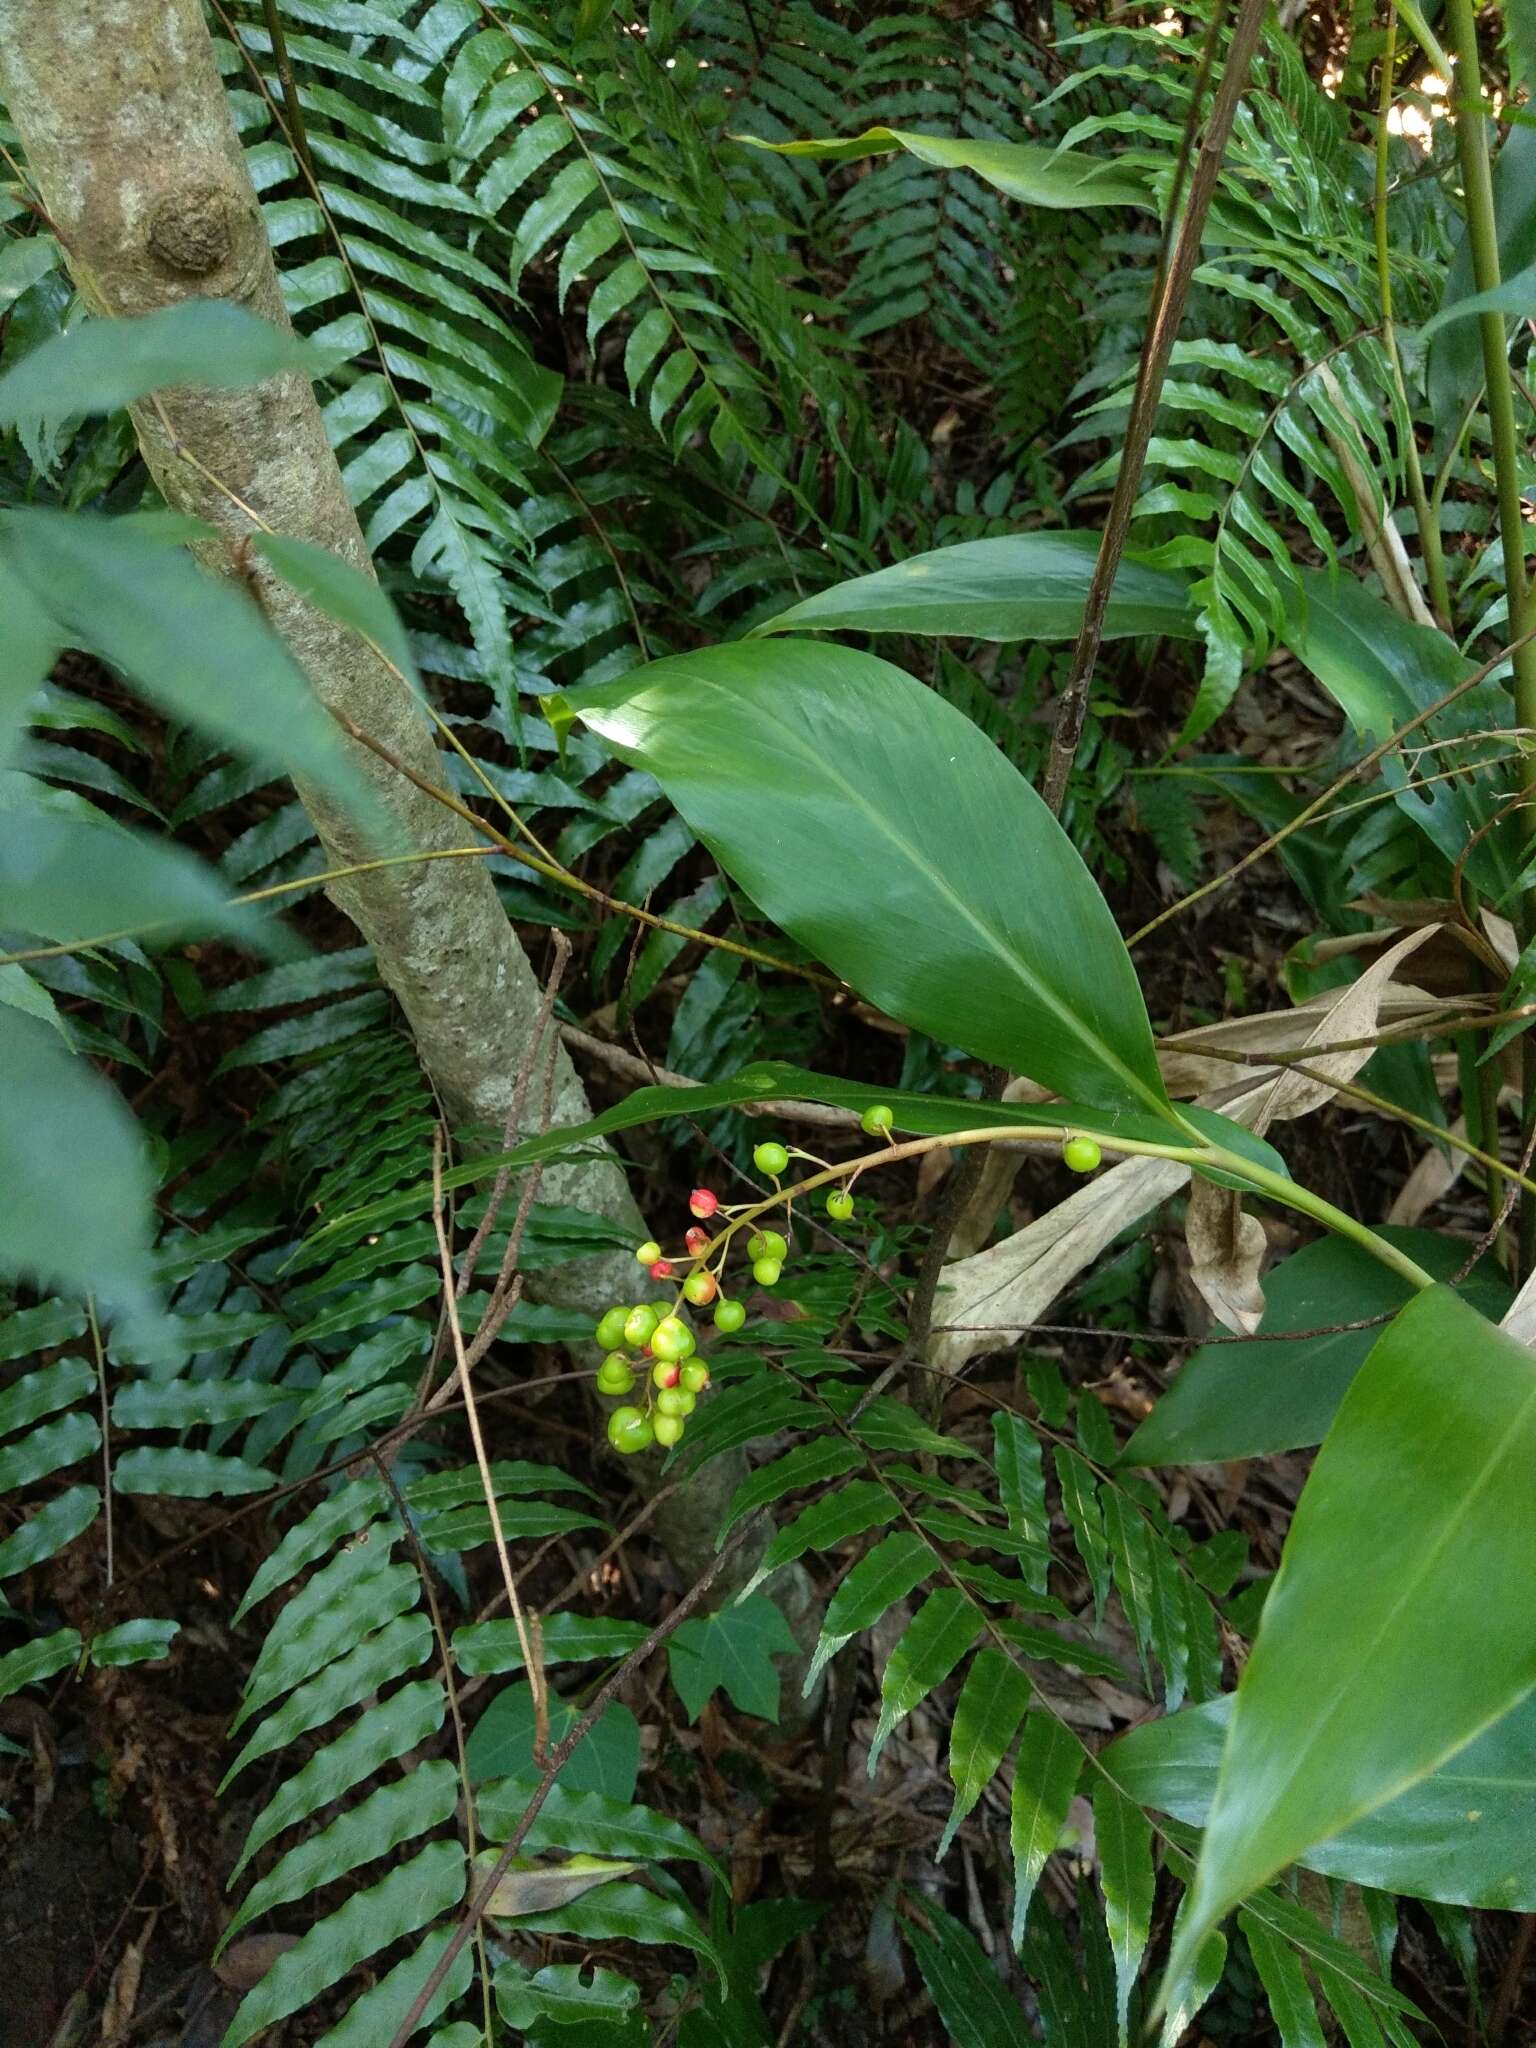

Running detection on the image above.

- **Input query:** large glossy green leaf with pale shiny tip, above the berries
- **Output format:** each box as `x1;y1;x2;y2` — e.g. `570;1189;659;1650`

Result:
569;641;1182;1137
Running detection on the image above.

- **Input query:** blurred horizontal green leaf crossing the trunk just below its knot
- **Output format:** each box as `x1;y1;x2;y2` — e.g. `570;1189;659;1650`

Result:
0;299;326;432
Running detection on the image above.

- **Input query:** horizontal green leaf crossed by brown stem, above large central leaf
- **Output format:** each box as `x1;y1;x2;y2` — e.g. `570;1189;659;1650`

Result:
750;530;1198;641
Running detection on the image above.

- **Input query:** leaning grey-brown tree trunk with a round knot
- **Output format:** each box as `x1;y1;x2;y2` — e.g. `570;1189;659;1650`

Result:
0;0;645;1307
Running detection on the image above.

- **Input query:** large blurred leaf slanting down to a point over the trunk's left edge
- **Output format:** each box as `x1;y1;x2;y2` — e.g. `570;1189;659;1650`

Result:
0;507;365;801
